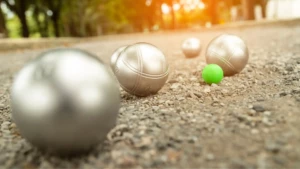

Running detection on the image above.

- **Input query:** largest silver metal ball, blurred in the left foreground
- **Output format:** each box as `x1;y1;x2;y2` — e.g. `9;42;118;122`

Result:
11;49;120;155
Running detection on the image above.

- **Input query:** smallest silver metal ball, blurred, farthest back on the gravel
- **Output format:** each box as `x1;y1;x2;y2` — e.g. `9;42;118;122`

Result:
181;38;201;58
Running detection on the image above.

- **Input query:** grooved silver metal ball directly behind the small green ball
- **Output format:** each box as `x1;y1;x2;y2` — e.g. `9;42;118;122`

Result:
206;34;249;76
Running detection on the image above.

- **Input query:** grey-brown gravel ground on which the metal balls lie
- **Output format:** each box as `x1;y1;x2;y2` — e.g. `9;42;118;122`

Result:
0;22;300;169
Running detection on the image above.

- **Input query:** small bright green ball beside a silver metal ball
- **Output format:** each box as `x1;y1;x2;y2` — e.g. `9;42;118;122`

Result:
202;64;224;84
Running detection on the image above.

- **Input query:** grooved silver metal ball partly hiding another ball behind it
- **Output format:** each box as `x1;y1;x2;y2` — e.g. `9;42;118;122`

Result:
114;43;169;96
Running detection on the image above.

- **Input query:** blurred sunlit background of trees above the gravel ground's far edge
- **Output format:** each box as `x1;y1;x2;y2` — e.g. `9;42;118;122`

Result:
0;0;300;38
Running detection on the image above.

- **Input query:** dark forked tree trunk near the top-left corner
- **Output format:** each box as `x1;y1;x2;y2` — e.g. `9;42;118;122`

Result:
2;0;31;38
